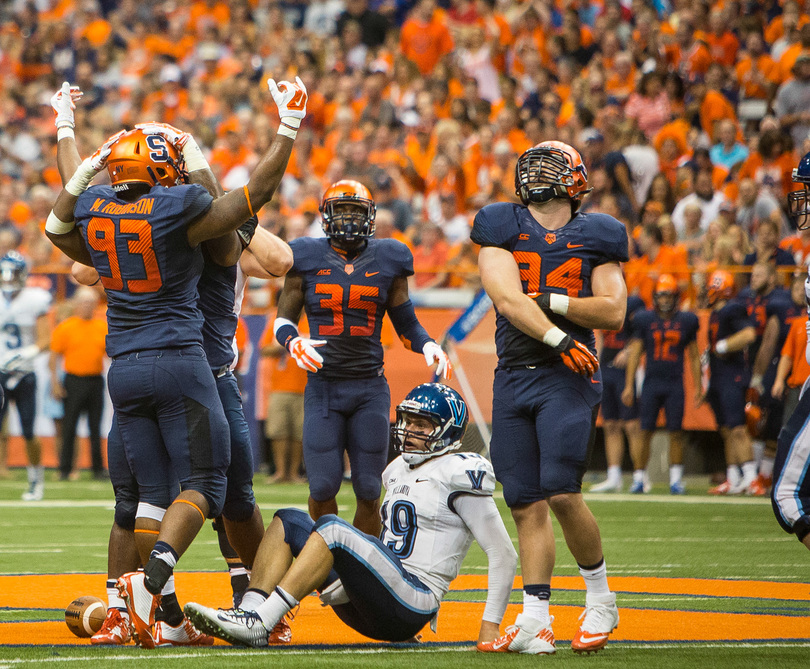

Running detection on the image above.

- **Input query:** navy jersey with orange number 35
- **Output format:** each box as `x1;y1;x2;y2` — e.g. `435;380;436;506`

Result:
290;237;413;378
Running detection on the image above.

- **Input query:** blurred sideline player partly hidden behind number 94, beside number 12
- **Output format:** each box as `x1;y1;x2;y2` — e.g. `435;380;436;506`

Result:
589;295;644;492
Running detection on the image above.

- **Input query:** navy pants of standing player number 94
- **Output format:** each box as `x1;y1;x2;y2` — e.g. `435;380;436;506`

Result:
490;362;601;507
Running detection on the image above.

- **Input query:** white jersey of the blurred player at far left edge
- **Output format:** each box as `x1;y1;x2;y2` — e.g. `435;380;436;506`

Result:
0;288;51;374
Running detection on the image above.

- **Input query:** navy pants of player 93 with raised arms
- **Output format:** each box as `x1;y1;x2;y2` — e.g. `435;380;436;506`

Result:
107;346;230;518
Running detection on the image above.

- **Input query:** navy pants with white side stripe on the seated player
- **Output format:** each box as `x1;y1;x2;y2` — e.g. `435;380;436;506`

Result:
276;509;439;641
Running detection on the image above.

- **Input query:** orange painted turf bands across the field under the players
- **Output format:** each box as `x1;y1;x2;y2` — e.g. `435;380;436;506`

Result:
0;572;810;645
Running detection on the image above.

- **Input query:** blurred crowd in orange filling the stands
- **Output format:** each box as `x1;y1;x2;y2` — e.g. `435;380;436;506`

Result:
0;0;810;303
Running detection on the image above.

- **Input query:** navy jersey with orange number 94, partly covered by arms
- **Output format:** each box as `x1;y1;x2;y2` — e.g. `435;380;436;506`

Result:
470;203;628;367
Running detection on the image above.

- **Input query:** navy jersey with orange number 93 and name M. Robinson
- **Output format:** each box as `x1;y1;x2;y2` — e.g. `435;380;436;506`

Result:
74;185;213;357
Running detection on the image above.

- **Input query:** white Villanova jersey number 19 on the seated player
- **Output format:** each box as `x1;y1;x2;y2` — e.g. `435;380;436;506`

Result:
380;453;495;600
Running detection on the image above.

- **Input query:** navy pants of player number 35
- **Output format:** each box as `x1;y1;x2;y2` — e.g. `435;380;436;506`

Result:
304;374;391;502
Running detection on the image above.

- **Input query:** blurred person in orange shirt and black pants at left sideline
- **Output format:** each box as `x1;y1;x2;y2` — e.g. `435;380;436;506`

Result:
50;287;107;481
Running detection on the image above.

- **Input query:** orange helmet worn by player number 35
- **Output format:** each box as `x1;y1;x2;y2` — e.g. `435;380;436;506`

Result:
318;179;377;243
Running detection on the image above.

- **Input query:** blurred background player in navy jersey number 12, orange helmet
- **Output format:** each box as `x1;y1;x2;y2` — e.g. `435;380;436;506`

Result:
622;274;703;495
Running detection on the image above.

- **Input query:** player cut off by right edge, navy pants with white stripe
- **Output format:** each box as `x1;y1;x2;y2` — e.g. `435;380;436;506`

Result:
771;153;810;548
